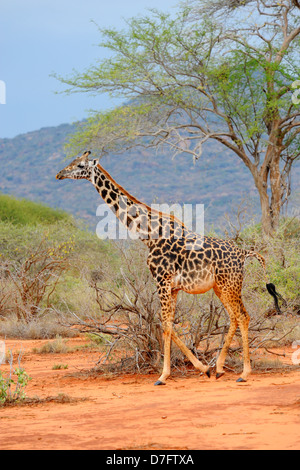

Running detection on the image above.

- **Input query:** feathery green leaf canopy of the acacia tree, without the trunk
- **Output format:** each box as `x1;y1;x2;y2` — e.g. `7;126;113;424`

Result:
57;5;300;158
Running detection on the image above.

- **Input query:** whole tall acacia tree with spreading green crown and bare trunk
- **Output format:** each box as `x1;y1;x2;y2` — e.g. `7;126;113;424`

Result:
59;0;300;235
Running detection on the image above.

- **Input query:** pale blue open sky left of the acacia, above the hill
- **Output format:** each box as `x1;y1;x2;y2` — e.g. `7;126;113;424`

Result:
0;0;178;138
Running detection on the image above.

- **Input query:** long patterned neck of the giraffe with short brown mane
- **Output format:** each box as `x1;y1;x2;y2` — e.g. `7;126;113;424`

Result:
91;164;184;245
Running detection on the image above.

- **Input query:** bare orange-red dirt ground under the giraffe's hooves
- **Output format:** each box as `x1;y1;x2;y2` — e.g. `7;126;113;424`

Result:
0;338;300;450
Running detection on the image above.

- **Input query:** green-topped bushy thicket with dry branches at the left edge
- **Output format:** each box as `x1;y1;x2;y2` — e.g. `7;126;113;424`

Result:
0;196;117;338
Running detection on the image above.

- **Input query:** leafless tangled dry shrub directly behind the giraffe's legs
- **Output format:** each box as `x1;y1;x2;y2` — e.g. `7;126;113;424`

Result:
61;242;296;372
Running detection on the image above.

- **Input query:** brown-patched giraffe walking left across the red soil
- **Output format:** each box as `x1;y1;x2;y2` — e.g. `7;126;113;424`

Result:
56;151;281;385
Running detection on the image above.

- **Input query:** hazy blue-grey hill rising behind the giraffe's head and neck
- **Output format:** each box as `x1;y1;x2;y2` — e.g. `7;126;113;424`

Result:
0;124;300;228
